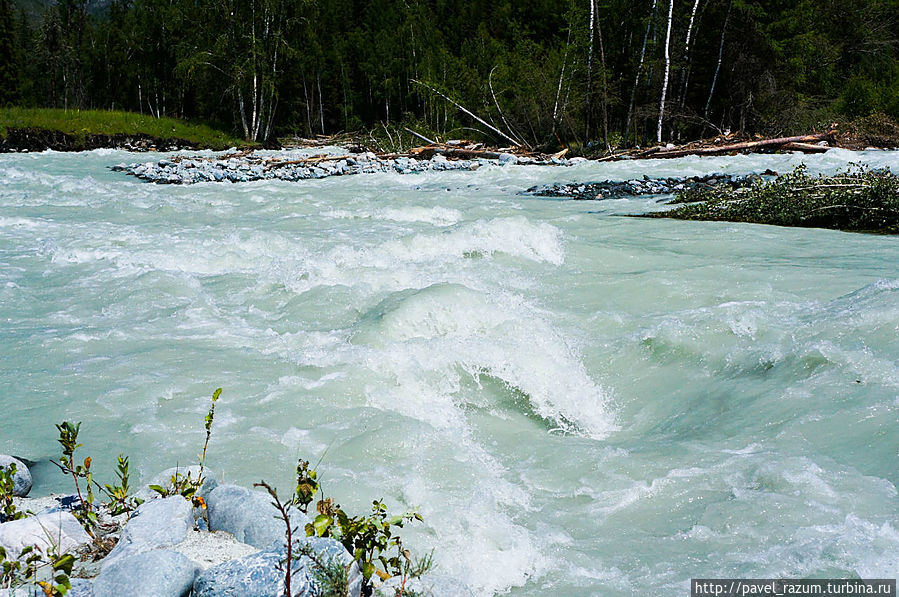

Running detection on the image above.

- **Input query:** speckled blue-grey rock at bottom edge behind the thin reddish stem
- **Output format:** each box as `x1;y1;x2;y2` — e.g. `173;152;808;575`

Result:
193;551;315;597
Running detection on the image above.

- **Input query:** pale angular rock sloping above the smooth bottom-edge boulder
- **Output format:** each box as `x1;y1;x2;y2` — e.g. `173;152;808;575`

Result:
103;495;193;570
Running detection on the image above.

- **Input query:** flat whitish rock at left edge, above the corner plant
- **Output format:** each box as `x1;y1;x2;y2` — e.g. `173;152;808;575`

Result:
0;512;91;557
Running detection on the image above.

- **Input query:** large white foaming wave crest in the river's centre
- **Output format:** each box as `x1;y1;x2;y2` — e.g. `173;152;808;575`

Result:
354;284;615;438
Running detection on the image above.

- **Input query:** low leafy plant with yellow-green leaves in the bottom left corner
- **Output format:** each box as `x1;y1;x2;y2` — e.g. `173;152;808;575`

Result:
0;545;75;597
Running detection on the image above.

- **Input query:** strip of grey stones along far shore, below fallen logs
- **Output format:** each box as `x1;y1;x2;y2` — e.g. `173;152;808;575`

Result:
110;152;586;184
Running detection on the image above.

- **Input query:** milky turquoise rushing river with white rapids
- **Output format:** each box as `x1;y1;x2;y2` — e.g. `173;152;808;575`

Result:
0;150;899;596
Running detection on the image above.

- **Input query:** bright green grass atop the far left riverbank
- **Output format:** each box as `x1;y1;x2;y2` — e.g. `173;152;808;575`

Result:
0;108;252;150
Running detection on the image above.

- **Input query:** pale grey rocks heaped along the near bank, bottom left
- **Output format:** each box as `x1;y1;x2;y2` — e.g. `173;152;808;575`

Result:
0;456;473;597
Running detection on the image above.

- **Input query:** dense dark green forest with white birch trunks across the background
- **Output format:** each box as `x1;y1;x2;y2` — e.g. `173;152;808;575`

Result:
0;0;899;148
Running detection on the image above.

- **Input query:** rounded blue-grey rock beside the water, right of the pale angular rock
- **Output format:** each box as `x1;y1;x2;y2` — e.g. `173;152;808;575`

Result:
206;485;311;549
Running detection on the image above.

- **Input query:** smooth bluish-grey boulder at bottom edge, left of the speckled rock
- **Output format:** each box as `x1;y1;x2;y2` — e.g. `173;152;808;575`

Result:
93;549;199;597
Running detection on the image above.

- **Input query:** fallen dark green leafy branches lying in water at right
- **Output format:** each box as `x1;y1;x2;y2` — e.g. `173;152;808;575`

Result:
652;166;899;234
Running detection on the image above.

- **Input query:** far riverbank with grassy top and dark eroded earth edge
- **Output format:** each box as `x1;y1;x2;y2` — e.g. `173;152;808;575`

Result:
0;108;258;153
